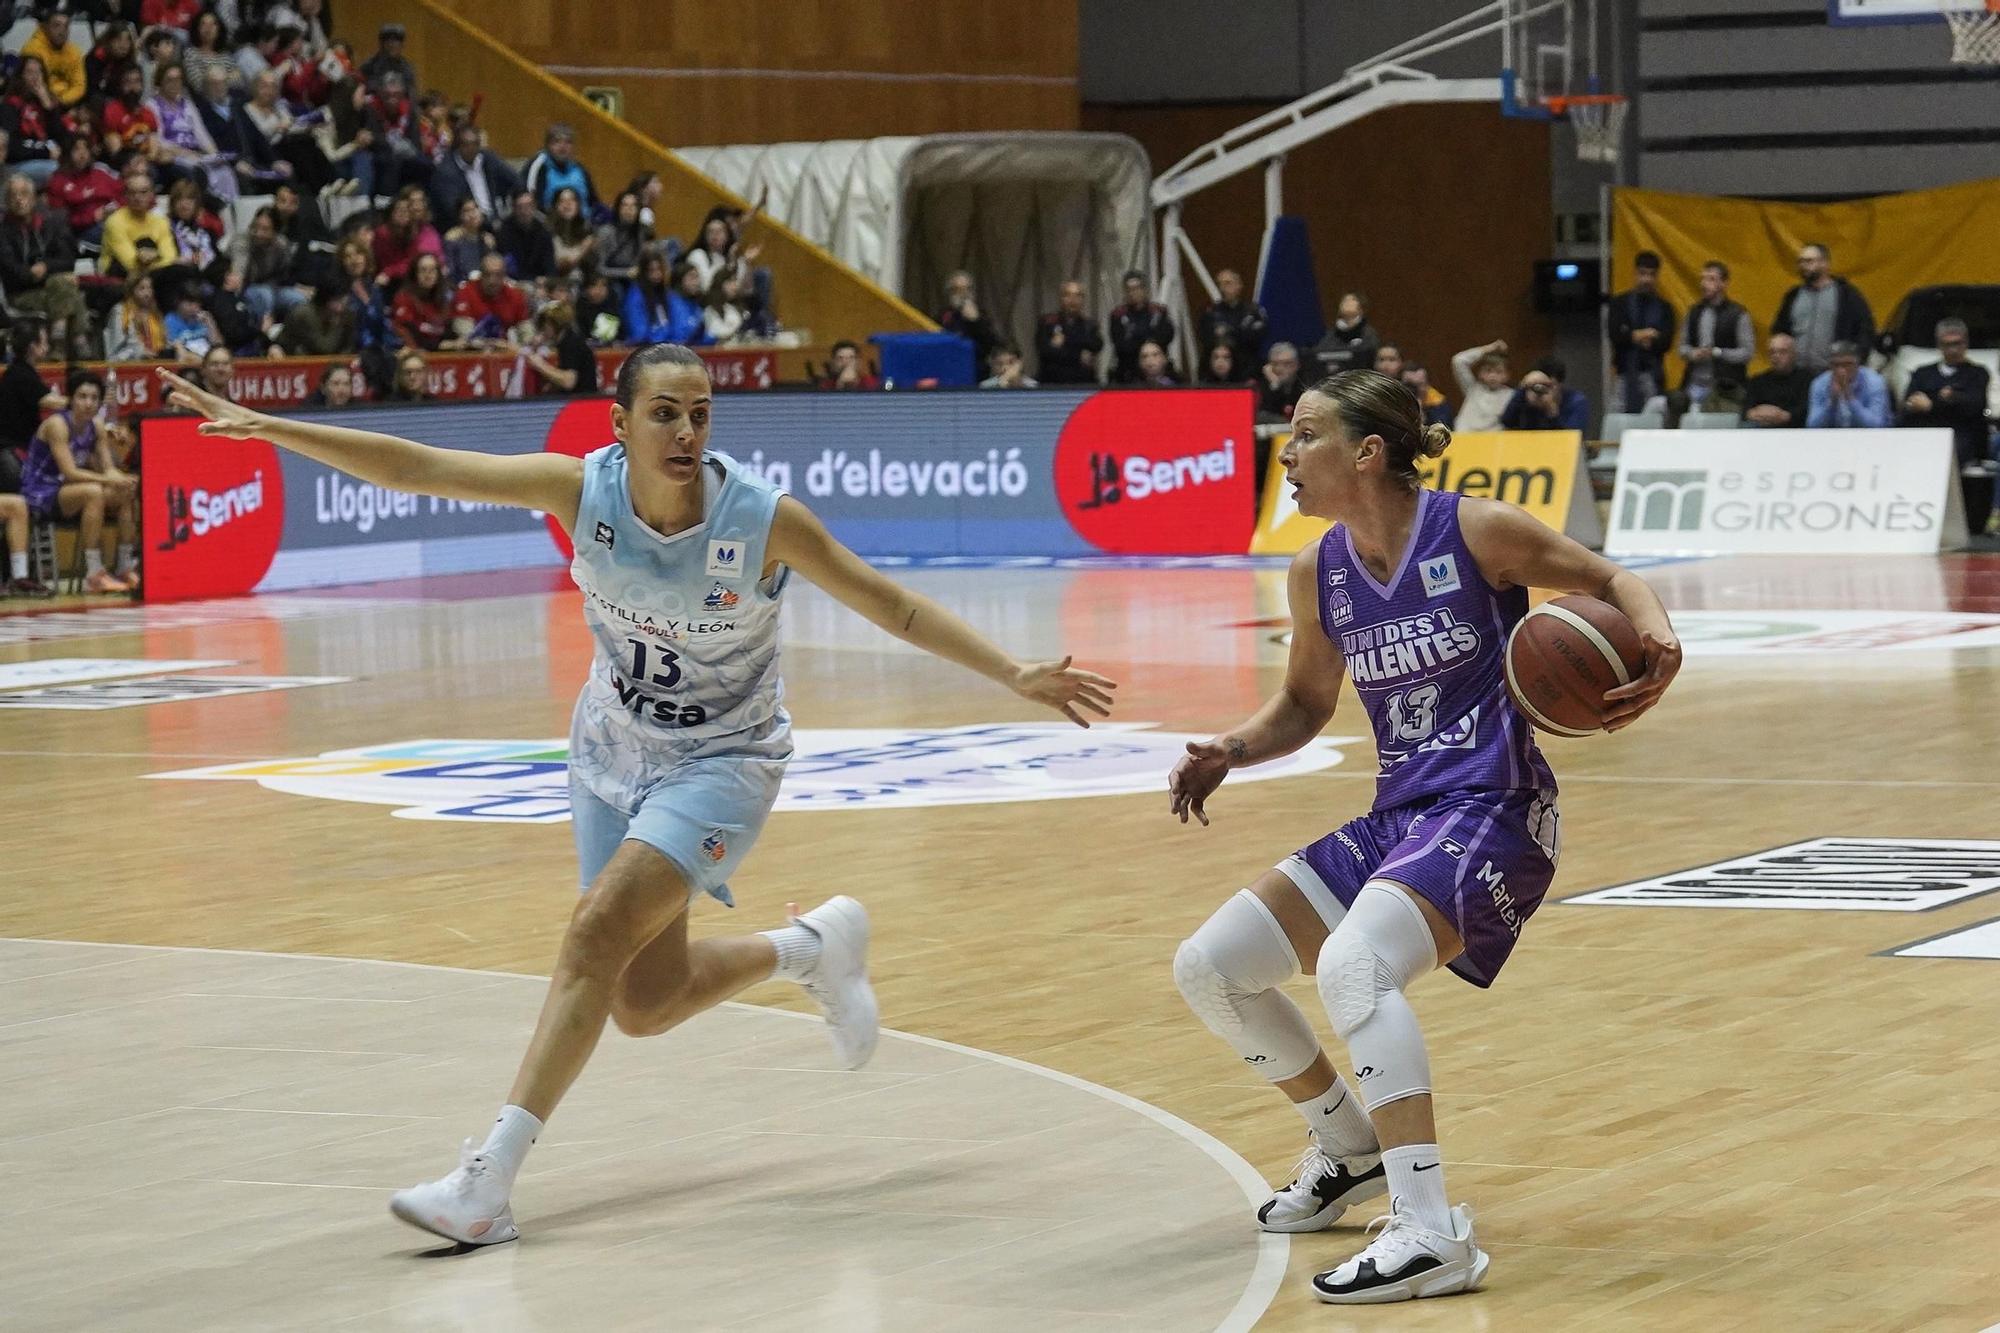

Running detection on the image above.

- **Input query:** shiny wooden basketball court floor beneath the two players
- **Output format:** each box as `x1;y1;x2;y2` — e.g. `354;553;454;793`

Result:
0;556;2000;1329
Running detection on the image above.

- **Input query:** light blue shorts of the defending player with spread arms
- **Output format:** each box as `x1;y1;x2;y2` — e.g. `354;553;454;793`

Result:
570;731;792;907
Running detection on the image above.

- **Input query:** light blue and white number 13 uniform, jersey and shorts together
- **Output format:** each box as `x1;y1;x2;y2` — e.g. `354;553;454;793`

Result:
570;444;792;901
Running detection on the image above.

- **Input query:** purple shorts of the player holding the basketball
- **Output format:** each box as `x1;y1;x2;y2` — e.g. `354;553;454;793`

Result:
1278;791;1562;987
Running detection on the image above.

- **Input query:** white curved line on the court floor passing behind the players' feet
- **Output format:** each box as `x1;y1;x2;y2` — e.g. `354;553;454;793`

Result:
0;935;1292;1333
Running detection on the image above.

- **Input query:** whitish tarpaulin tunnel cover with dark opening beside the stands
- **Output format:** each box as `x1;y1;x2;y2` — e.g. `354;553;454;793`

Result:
678;134;1178;374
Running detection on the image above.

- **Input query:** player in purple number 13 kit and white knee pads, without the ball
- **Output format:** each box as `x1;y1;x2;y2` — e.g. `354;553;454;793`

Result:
1168;370;1680;1305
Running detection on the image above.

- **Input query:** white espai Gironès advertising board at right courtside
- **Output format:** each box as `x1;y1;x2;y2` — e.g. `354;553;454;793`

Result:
1604;428;1966;556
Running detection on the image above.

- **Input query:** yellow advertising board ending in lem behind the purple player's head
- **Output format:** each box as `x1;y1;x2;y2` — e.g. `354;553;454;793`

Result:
1250;430;1584;554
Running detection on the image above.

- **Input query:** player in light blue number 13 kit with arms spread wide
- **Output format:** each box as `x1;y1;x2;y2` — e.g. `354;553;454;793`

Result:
160;352;1116;1245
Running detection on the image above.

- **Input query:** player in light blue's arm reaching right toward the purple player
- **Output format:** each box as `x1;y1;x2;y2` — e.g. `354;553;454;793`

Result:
768;496;1118;727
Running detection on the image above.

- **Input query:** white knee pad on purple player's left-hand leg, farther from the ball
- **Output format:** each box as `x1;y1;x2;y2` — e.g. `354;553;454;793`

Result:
1174;889;1320;1083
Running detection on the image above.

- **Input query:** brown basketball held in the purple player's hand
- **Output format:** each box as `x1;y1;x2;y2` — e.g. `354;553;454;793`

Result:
1506;596;1646;737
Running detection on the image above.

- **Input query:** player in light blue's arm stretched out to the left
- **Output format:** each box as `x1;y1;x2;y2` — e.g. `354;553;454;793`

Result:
160;370;584;530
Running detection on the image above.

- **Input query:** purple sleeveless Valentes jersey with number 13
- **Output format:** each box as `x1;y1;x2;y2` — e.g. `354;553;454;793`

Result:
1320;488;1556;811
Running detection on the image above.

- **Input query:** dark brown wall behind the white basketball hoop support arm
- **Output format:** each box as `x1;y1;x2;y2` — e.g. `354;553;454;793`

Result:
1082;102;1554;396
